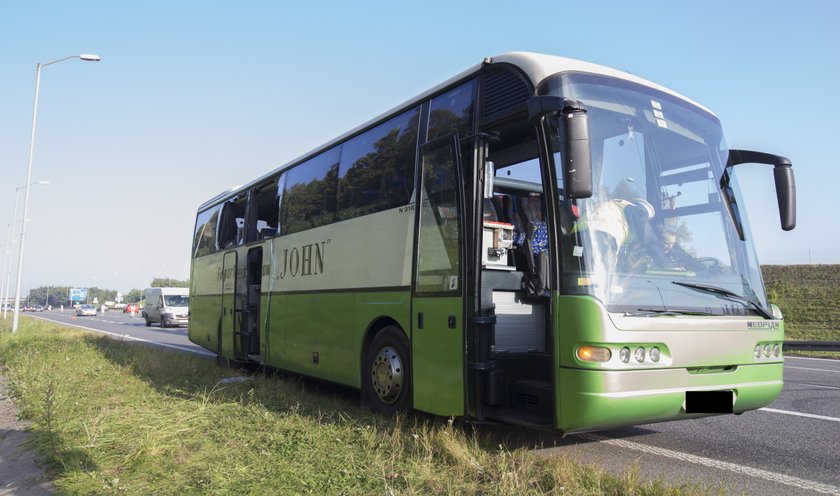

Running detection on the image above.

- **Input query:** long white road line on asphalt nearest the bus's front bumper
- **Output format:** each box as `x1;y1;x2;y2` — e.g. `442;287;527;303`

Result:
578;433;840;495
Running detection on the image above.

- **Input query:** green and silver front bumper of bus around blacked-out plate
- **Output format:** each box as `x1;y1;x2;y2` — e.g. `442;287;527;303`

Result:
557;362;783;433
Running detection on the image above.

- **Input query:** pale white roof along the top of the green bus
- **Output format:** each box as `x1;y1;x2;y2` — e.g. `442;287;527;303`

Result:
198;52;714;212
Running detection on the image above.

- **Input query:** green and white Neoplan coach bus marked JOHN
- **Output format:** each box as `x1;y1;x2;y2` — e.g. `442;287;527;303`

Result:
189;53;796;432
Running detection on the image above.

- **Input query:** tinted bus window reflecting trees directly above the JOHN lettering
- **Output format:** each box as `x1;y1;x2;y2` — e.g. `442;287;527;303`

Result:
280;148;339;234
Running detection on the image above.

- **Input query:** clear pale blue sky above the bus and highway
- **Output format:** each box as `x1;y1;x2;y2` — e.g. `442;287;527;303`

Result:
0;0;840;291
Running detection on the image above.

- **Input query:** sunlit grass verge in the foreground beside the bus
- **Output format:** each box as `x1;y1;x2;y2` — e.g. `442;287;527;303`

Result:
0;318;719;495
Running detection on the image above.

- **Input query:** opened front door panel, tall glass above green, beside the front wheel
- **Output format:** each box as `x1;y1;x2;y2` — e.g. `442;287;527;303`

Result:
411;134;465;415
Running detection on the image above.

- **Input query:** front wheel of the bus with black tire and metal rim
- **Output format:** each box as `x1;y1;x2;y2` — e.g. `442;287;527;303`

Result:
362;326;412;413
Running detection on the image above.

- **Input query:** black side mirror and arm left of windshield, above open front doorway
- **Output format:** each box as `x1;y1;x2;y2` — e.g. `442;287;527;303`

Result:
528;96;592;198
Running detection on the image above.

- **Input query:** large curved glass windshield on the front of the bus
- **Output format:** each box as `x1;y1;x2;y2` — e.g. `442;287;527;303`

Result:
544;74;770;317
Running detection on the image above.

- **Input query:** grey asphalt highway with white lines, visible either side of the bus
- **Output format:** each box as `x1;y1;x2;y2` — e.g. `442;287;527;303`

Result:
26;310;840;496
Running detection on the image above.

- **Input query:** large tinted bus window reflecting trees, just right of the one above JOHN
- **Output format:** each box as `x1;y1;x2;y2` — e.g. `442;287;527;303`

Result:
336;109;420;220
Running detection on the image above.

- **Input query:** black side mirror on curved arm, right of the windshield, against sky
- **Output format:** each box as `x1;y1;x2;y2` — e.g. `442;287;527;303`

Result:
720;150;796;232
